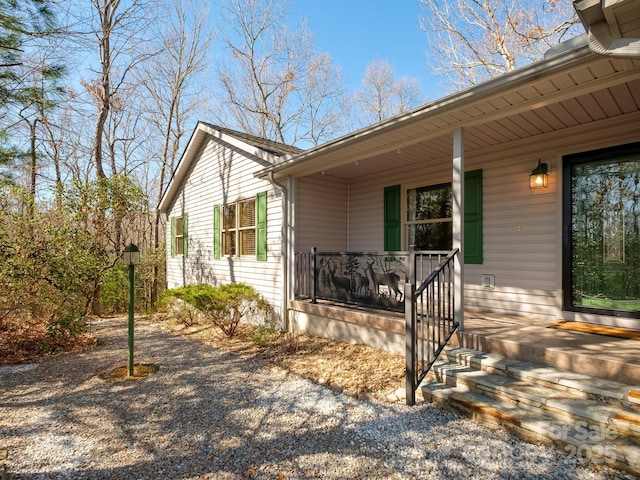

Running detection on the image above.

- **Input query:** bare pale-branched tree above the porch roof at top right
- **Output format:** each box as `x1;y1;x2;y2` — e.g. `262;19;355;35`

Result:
420;0;578;90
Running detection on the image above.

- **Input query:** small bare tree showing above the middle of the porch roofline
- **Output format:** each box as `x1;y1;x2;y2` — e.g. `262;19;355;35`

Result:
354;60;423;125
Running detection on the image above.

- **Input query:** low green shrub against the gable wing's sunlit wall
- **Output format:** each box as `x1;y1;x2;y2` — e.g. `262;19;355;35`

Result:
160;283;271;337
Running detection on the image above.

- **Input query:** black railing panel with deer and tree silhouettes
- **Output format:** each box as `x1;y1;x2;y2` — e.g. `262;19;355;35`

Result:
311;252;409;312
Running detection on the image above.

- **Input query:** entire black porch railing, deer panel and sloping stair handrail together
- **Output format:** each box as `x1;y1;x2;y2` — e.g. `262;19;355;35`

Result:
295;248;459;405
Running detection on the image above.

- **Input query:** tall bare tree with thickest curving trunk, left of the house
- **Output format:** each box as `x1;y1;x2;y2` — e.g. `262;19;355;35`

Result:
69;0;157;313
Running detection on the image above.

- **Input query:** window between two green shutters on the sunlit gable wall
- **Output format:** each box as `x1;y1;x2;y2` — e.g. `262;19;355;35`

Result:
222;199;256;256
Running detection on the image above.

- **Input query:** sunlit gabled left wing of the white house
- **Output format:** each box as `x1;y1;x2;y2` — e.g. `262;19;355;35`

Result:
159;122;300;322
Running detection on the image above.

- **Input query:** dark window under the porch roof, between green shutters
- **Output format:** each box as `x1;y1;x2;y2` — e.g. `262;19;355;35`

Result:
406;184;453;250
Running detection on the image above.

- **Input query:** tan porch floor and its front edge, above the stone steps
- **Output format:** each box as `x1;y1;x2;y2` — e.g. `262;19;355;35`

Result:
290;301;640;385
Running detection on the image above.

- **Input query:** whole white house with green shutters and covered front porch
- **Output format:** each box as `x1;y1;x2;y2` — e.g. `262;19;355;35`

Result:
159;0;640;329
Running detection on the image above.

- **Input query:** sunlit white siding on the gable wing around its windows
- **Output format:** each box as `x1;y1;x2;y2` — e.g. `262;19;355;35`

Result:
167;134;283;314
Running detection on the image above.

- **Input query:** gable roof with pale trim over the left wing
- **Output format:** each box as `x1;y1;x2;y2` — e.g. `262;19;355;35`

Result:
158;121;302;213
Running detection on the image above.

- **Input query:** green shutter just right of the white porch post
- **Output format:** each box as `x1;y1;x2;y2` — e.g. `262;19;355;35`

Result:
464;170;483;264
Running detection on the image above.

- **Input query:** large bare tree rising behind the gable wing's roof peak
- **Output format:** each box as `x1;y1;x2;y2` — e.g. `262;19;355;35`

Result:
219;0;343;144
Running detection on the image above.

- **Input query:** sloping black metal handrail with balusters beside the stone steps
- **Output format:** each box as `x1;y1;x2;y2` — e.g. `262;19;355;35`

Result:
405;249;459;405
